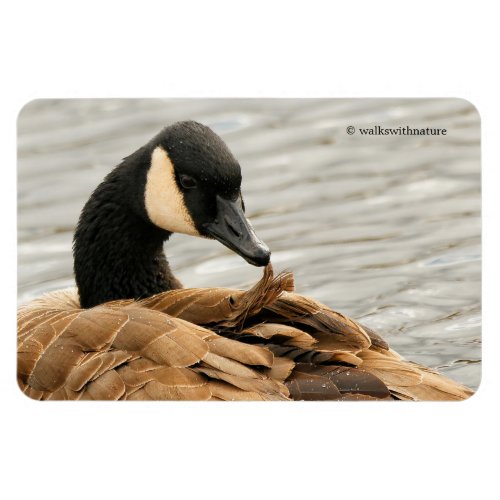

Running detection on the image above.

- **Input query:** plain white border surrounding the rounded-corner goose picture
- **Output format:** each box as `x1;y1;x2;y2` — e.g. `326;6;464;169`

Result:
0;0;500;499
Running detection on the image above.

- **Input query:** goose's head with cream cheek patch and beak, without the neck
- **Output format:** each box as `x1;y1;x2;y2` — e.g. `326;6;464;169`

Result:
145;121;270;266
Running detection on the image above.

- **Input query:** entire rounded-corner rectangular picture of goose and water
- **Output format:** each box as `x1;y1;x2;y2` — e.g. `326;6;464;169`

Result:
18;98;481;402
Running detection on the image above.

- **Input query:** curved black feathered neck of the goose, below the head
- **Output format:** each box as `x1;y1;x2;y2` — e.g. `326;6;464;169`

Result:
73;160;181;308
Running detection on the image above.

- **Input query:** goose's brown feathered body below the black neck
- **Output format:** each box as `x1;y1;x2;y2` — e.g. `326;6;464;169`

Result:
18;266;472;401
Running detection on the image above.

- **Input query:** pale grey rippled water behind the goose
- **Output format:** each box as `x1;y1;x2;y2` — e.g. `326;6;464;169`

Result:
18;99;481;388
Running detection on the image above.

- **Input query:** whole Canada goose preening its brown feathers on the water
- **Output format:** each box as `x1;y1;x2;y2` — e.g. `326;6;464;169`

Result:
18;121;472;400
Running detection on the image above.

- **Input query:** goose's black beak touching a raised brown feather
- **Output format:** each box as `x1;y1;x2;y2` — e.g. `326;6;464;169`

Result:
203;195;271;266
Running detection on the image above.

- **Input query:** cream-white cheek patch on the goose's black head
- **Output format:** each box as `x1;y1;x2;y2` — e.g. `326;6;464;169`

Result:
144;146;201;236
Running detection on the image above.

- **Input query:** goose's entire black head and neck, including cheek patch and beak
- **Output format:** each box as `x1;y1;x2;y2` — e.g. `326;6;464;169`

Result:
73;121;271;308
